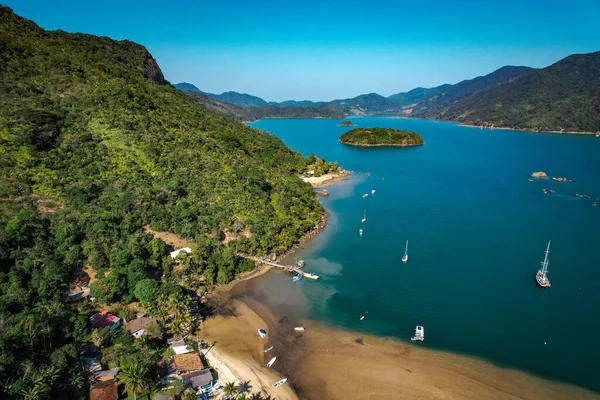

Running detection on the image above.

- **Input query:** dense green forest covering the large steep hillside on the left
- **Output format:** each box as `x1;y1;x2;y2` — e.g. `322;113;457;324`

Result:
0;7;323;399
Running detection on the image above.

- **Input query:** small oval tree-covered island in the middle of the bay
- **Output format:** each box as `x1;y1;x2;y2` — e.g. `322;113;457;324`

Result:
340;128;425;146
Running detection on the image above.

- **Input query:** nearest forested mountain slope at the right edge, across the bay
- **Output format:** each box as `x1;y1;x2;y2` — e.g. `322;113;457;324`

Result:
420;52;600;132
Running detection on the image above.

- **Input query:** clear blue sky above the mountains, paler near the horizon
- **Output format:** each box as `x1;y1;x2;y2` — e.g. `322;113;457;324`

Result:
0;0;600;101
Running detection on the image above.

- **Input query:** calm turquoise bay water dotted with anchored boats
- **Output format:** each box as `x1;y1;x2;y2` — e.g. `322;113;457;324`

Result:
251;117;600;391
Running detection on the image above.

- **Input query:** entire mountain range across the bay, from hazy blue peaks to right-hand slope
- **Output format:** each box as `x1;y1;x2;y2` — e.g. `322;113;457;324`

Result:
175;52;600;132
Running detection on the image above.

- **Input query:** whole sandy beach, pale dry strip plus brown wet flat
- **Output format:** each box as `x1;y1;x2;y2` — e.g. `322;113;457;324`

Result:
202;271;600;400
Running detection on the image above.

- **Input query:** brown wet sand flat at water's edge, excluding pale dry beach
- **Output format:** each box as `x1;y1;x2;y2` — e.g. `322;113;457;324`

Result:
221;281;600;400
